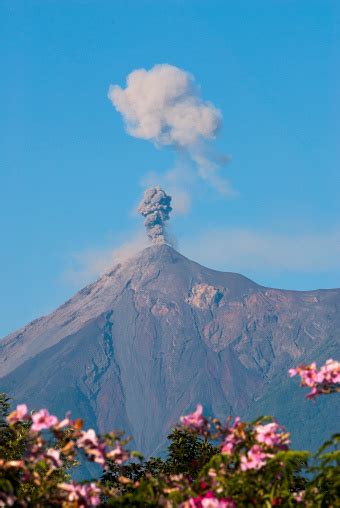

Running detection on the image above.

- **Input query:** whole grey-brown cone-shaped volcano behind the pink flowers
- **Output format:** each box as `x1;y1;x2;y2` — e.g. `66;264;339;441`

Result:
0;244;340;455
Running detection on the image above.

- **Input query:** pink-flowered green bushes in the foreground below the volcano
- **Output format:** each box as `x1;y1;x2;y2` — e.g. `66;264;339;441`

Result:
0;360;340;508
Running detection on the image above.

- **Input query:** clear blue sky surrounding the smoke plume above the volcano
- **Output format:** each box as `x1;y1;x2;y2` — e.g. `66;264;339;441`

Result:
0;0;340;336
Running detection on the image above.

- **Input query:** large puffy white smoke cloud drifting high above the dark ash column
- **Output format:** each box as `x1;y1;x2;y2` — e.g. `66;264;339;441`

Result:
108;64;233;198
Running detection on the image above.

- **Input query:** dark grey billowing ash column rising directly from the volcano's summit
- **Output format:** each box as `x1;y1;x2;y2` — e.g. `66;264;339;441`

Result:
138;186;172;244
